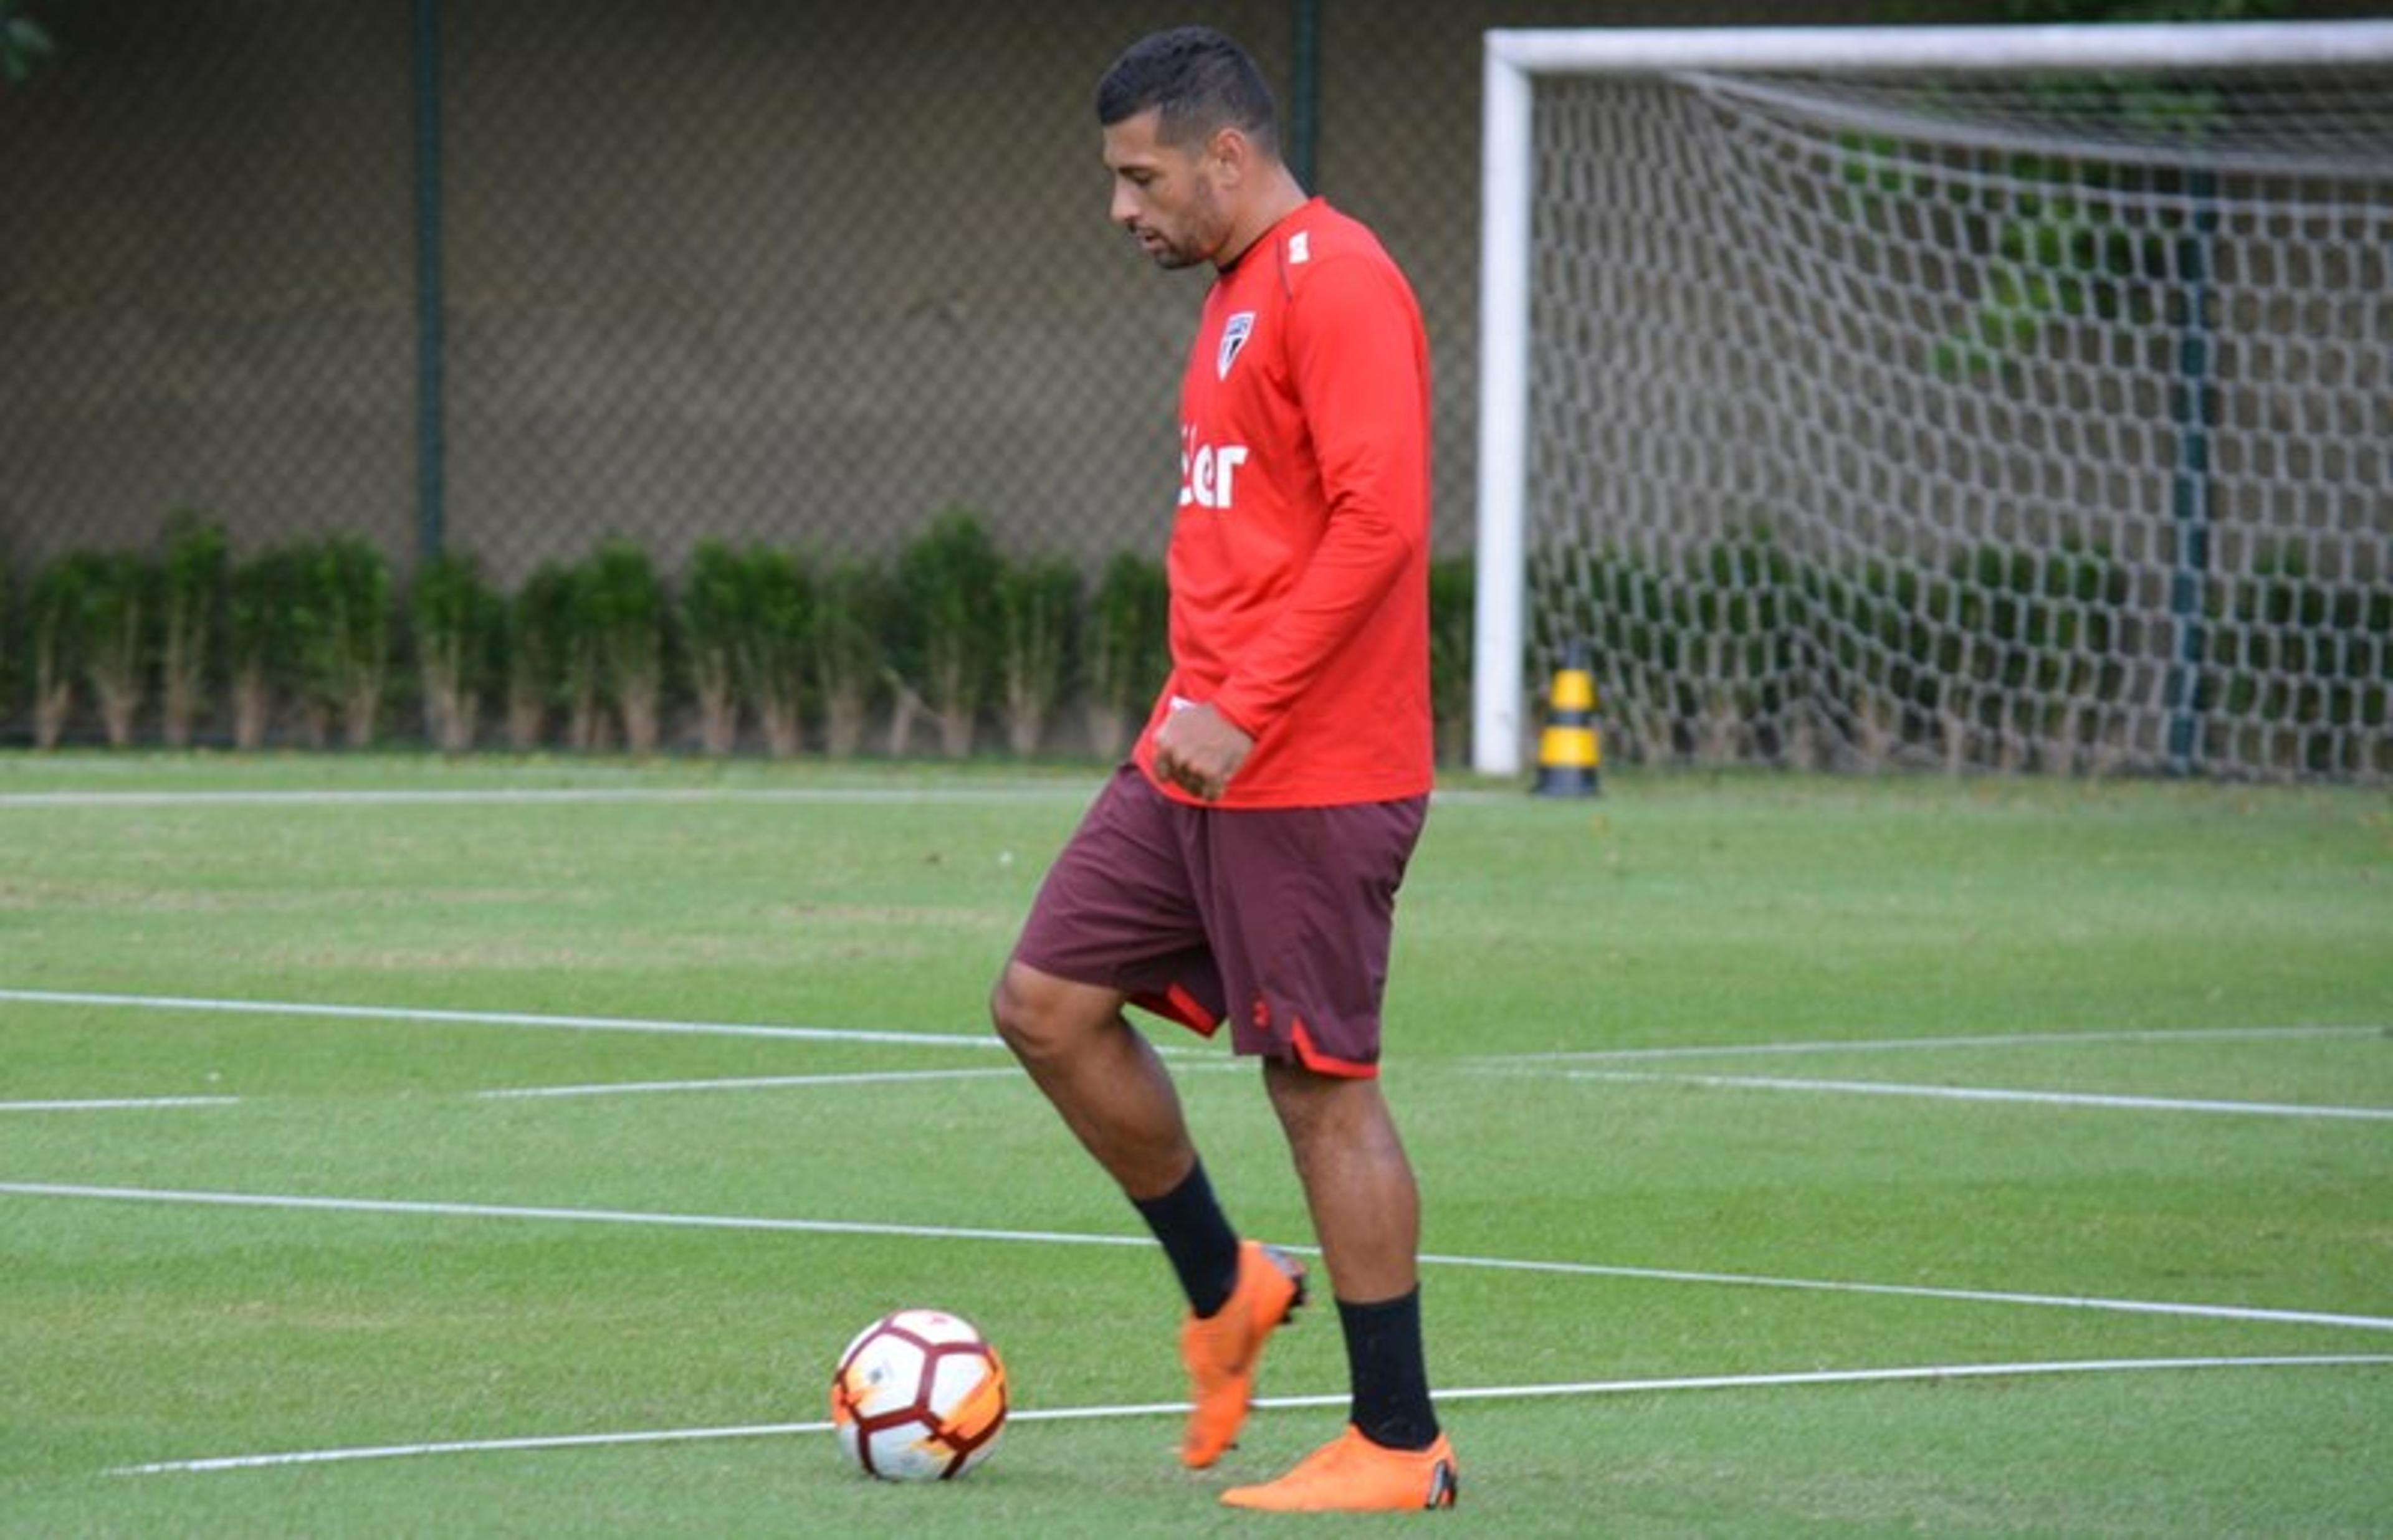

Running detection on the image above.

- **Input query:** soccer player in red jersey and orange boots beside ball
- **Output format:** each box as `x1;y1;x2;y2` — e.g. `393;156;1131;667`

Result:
991;26;1455;1509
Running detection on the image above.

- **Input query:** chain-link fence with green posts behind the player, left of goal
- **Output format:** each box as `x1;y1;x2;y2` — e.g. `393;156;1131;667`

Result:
0;0;2383;751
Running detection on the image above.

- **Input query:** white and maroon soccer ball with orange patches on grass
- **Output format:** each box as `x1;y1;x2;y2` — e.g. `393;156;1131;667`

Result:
830;1311;1005;1480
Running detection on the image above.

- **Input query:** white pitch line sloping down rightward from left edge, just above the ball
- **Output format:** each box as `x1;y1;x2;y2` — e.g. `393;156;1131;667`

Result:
19;1181;2393;1332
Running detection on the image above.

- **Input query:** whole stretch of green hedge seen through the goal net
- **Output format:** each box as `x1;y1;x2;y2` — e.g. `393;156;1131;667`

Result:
1532;528;2393;775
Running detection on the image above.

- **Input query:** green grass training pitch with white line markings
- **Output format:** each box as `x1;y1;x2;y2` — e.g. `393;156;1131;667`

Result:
0;756;2393;1535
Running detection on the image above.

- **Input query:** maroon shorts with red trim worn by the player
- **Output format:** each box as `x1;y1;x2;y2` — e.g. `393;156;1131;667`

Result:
1015;765;1428;1078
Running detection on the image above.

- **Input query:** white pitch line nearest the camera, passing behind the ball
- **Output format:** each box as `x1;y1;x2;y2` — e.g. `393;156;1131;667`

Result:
108;1354;2393;1475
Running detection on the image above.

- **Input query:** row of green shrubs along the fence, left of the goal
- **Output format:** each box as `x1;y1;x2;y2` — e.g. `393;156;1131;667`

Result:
0;510;1469;758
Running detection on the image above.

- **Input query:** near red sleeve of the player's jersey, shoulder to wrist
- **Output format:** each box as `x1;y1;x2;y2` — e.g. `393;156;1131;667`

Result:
1213;259;1428;739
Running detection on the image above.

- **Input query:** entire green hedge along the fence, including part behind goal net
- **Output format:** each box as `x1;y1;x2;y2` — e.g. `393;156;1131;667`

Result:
14;514;2393;777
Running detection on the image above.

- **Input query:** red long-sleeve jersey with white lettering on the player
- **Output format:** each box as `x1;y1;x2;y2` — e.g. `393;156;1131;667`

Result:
1137;199;1433;808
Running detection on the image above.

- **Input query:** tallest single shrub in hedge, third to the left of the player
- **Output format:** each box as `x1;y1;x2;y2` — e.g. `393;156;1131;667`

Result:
897;510;1005;758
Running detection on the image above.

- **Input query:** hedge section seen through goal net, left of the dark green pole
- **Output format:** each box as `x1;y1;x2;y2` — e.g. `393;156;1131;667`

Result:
1532;528;2130;770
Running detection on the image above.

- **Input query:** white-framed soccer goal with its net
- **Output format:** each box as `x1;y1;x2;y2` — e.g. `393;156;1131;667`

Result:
1474;22;2393;782
